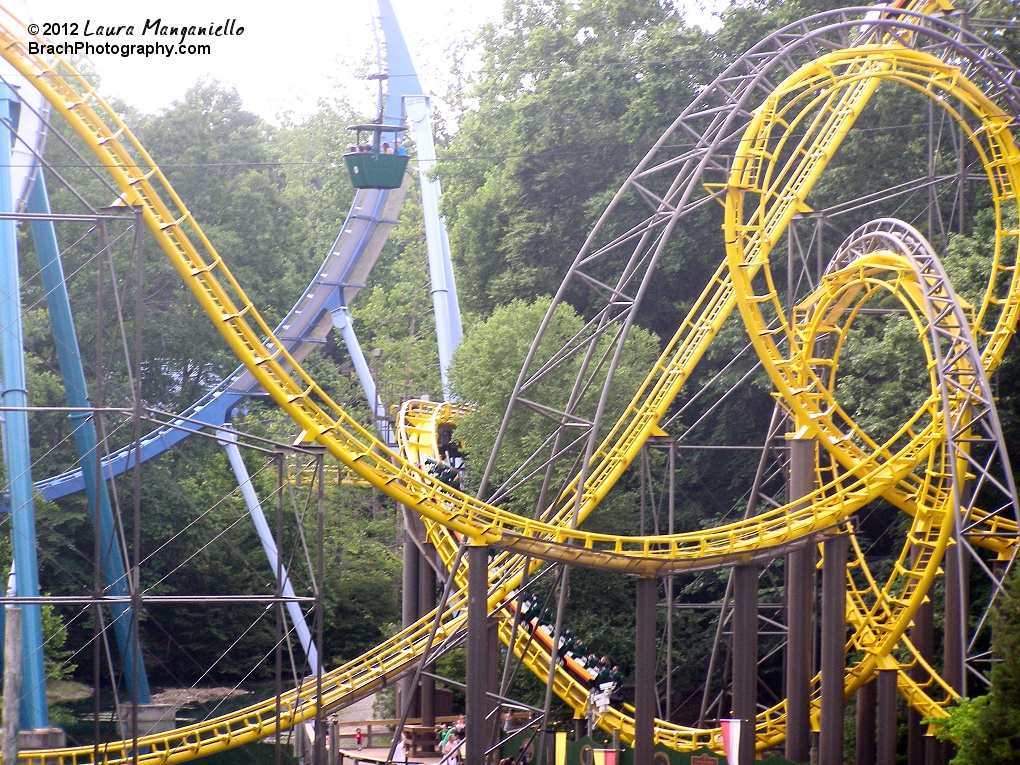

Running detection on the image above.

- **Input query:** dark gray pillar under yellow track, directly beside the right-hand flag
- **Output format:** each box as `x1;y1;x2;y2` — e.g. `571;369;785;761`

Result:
731;565;758;762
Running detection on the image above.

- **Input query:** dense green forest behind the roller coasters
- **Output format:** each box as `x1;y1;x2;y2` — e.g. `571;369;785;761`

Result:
5;0;1020;754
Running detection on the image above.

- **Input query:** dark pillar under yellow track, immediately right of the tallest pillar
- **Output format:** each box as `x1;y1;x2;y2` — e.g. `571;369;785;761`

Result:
818;533;848;765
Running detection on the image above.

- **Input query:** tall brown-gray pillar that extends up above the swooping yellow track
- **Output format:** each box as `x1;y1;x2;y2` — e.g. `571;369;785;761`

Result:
786;438;817;763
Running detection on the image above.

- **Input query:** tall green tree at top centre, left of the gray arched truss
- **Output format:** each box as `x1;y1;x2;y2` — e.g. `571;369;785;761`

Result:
442;0;721;329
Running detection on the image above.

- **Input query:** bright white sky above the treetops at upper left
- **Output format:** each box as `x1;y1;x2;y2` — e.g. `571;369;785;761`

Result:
23;0;722;121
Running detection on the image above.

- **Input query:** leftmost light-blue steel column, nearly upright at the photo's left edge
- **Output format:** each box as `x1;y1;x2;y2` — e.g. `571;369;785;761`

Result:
0;83;49;728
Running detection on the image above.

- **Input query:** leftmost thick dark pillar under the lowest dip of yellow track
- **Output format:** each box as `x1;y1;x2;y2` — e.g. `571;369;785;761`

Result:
464;545;489;765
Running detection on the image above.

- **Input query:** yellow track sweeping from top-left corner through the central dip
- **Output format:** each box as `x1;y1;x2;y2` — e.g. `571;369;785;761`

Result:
0;10;971;574
